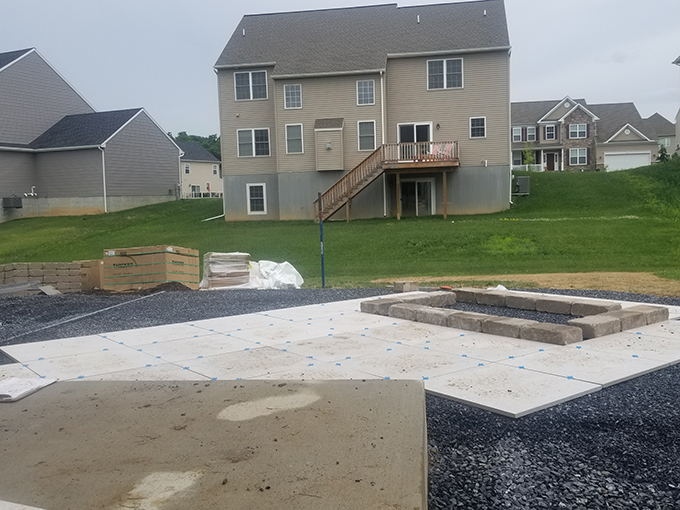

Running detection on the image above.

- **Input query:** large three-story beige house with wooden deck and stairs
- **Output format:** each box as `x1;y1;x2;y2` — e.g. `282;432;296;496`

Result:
215;0;510;220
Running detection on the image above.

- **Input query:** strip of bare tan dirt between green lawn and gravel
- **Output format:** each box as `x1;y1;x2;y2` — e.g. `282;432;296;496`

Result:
373;273;680;297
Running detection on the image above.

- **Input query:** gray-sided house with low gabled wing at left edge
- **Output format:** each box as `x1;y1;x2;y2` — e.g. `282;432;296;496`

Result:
0;48;180;222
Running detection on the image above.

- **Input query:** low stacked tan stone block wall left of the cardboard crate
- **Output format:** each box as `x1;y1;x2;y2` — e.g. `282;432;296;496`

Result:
0;262;82;293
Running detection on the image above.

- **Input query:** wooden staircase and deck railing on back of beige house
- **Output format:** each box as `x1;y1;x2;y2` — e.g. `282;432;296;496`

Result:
314;142;458;221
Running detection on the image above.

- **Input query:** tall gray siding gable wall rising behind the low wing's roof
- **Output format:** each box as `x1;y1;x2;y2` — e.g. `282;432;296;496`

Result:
0;52;94;143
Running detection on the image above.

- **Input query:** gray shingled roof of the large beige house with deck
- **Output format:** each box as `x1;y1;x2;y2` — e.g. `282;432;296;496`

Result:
215;0;510;77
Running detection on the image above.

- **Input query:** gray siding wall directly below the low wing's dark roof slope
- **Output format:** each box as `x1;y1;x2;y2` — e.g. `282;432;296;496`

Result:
35;149;104;198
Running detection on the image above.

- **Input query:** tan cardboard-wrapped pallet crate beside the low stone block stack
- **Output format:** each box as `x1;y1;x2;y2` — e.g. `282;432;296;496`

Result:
102;245;200;292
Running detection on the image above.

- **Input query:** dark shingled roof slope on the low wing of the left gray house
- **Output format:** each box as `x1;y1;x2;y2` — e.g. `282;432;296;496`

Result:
30;108;142;149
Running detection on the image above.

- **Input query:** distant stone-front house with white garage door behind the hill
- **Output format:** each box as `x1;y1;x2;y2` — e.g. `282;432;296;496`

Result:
511;97;665;171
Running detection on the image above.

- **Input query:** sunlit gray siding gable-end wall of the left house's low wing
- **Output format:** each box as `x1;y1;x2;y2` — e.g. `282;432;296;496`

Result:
106;112;179;196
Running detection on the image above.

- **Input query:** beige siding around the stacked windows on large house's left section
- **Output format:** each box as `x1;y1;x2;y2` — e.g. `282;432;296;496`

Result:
217;67;276;175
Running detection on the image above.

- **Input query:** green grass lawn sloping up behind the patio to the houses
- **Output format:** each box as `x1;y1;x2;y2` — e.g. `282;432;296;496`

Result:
0;163;680;287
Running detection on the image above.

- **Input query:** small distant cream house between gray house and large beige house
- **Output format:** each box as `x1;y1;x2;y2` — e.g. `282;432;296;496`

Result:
175;140;222;198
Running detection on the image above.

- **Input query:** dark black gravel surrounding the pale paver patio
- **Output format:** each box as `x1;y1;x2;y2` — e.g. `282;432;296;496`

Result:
0;289;680;510
